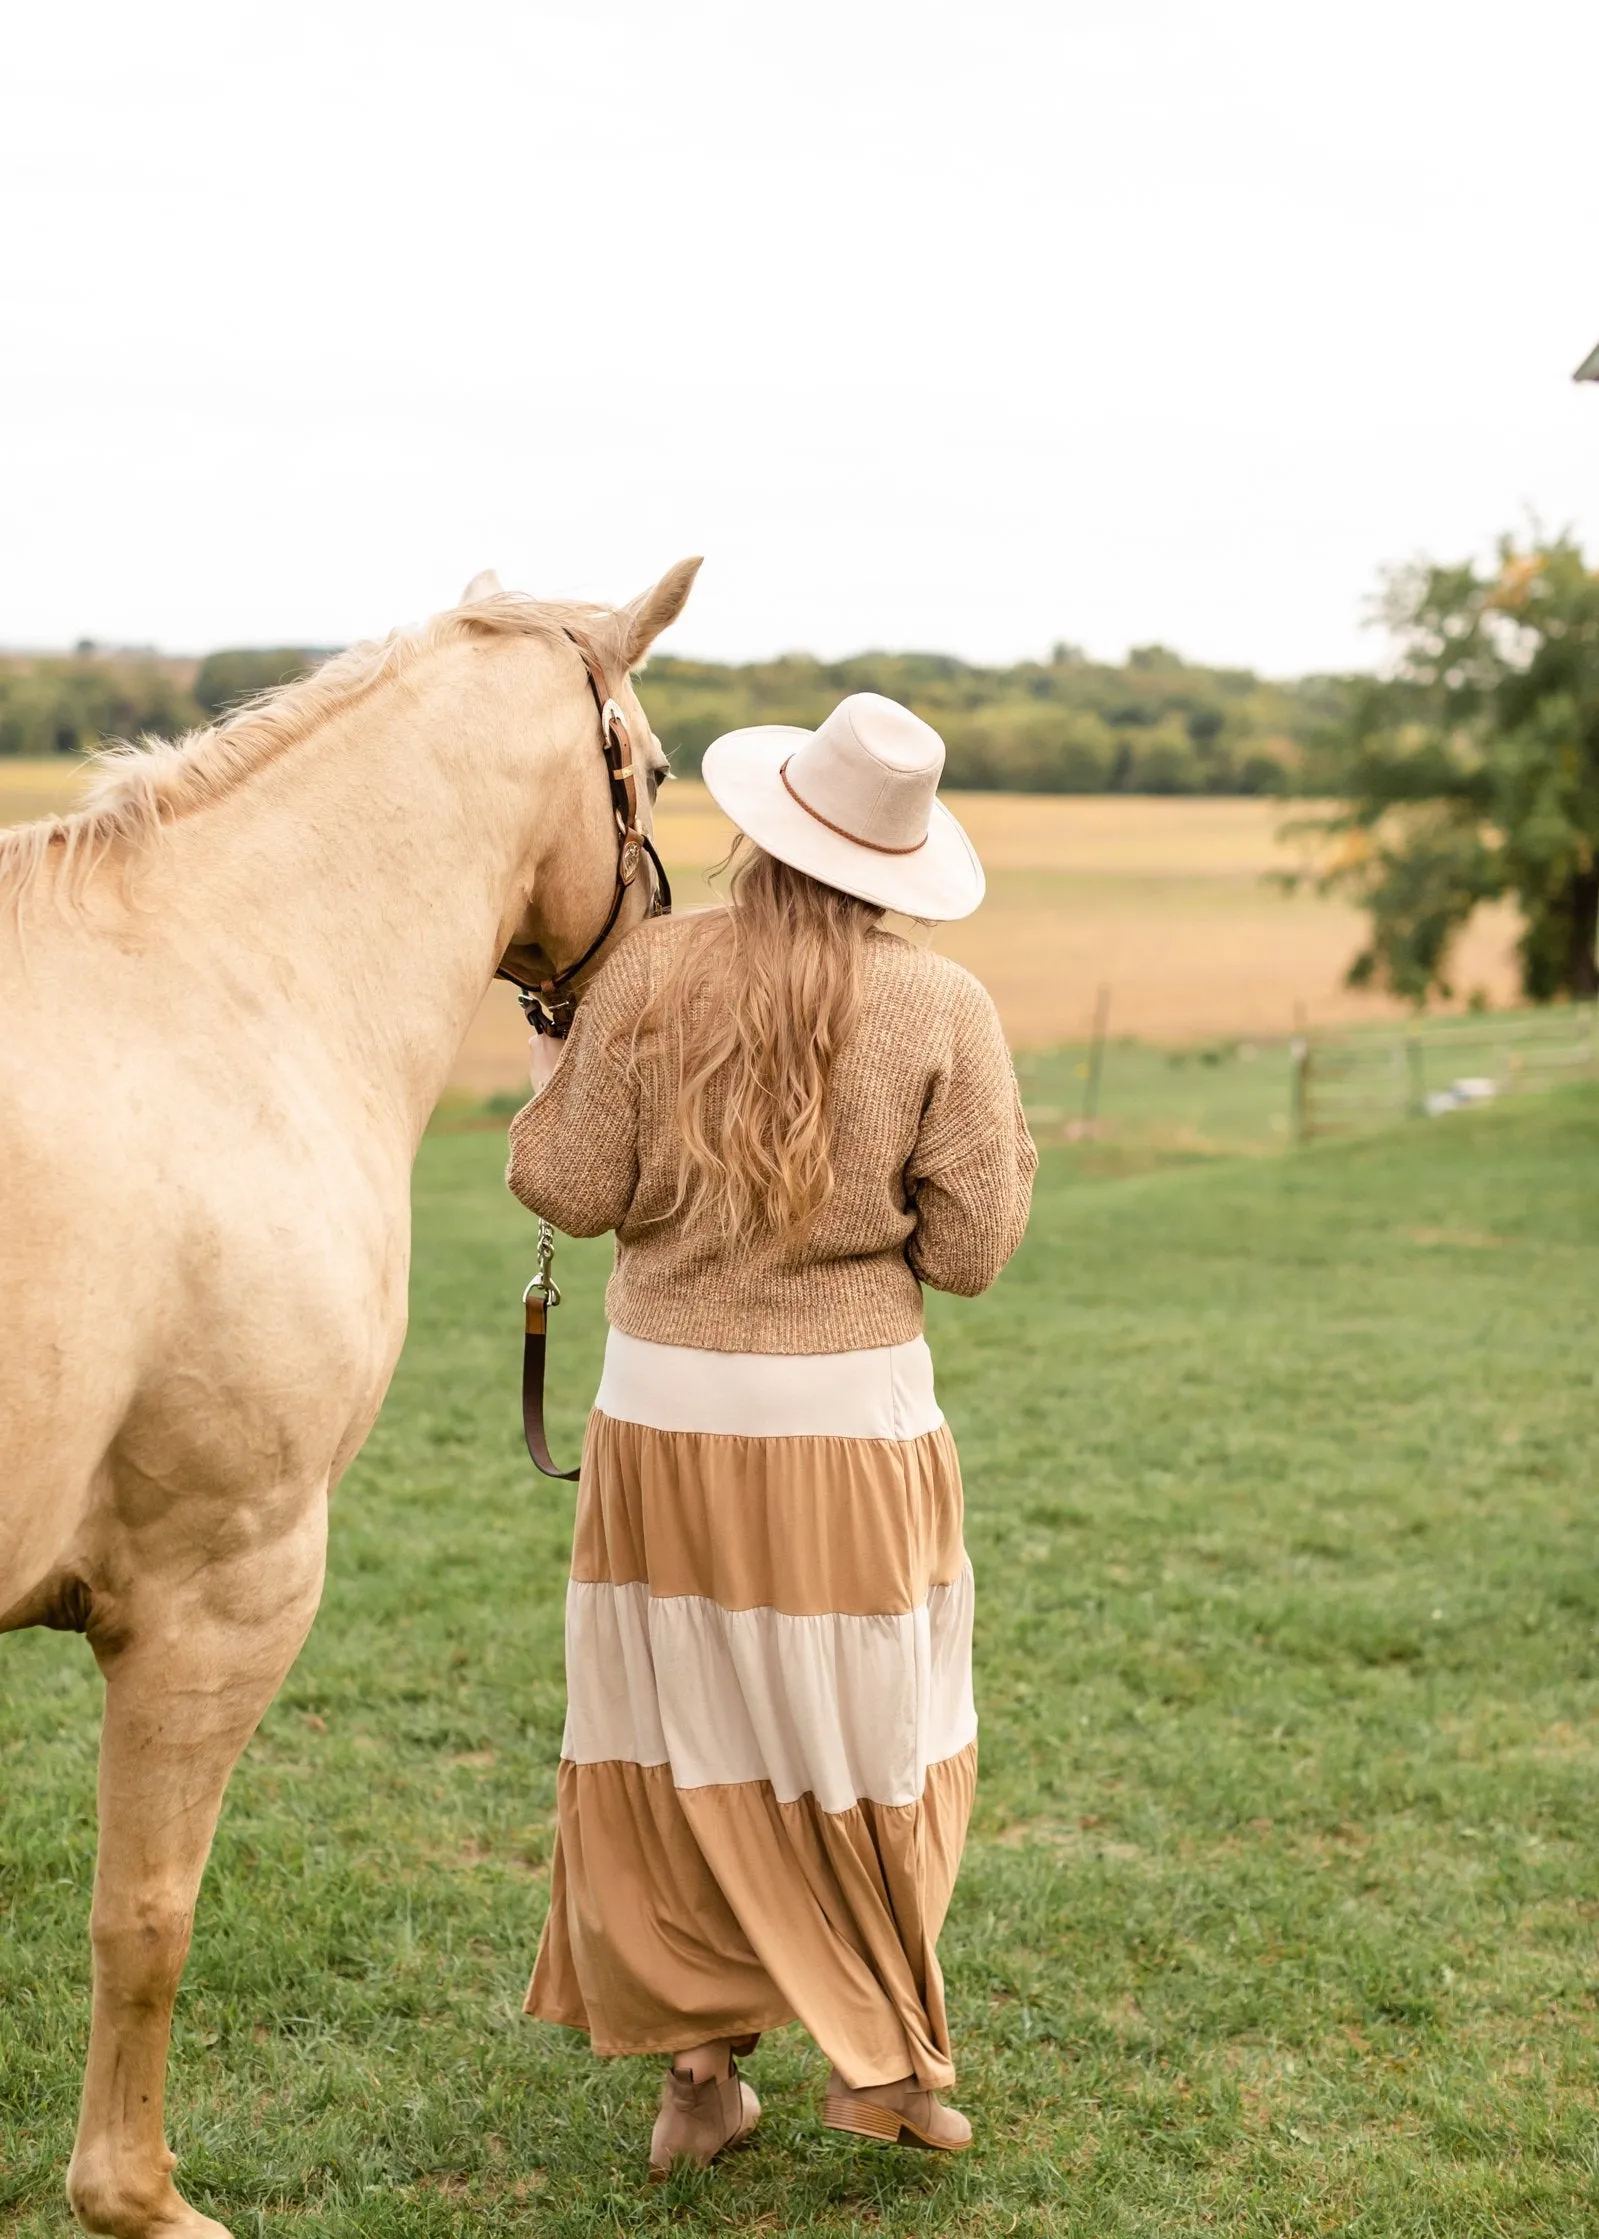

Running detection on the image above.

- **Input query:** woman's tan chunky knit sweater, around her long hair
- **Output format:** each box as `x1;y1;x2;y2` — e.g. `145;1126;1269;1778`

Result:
506;918;1037;1352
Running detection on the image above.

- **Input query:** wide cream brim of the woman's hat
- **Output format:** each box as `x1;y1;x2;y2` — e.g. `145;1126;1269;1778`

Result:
699;723;983;922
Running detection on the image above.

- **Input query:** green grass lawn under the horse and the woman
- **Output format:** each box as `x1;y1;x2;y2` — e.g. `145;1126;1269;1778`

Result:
0;1090;1599;2239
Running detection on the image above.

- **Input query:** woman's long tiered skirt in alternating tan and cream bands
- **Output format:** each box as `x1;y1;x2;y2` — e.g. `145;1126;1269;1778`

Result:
526;1330;976;2091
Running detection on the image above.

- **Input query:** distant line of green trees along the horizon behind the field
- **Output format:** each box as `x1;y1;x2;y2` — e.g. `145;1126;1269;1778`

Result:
0;645;1348;793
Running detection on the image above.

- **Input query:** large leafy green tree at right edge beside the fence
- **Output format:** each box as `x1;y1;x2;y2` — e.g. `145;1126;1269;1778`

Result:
1301;535;1599;1003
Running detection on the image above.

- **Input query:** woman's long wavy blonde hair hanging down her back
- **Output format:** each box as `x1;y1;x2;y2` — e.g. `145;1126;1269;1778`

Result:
638;835;882;1243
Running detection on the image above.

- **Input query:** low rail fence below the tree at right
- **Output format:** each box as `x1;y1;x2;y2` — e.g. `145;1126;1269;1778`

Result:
1290;1003;1599;1142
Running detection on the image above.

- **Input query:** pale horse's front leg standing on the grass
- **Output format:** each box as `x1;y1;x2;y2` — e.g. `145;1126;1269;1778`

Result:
67;1487;327;2239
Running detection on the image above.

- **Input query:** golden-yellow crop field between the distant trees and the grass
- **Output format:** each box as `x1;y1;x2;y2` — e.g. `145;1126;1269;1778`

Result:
0;761;1516;1095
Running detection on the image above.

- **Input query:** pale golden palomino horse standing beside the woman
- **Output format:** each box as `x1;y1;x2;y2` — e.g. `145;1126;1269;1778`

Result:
0;560;699;2239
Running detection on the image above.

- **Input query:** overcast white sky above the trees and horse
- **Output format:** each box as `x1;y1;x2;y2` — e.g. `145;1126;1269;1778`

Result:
0;0;1599;674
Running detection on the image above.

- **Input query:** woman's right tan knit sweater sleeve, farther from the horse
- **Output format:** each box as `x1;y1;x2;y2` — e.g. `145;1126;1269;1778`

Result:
905;981;1039;1299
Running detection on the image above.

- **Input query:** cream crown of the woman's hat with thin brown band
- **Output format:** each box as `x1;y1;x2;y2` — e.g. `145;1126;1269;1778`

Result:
784;692;943;855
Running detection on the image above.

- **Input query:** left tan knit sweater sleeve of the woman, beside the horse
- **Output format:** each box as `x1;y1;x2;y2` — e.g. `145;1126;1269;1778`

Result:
506;945;647;1236
